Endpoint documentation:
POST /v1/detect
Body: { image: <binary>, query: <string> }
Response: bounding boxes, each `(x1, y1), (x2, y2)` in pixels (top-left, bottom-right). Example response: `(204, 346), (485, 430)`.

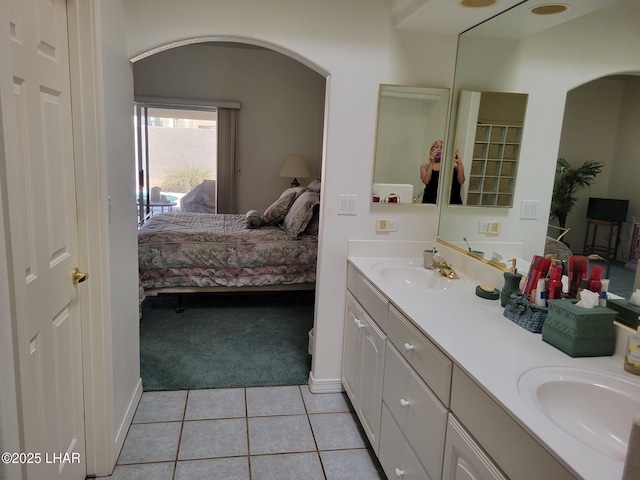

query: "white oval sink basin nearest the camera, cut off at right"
(518, 367), (640, 462)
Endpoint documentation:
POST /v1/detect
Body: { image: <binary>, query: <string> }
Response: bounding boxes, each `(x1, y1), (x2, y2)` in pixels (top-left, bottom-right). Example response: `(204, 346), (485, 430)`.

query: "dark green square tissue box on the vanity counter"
(542, 300), (616, 357)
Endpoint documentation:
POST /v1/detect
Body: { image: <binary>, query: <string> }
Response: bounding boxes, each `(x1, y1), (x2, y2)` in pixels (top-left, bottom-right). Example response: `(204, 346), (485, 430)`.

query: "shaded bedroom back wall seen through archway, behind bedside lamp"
(133, 44), (325, 213)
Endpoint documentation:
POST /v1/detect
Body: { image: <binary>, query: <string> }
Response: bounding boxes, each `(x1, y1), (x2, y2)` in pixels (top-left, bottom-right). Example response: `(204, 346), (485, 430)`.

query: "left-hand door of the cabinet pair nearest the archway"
(342, 292), (364, 408)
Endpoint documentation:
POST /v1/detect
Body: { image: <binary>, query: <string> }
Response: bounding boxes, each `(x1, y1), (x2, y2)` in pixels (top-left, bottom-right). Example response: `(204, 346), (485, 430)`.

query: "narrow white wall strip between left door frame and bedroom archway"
(99, 0), (140, 432)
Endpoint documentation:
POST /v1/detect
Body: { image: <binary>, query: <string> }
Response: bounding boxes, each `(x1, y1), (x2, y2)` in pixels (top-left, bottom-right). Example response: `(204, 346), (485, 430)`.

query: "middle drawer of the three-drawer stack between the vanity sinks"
(383, 342), (447, 478)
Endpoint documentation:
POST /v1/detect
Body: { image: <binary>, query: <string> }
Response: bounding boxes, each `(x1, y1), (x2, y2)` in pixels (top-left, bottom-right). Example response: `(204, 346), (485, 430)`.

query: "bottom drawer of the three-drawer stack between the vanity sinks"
(378, 403), (432, 480)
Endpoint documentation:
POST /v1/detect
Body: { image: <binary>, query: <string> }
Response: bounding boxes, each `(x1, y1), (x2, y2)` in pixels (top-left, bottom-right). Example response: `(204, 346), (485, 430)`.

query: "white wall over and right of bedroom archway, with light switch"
(121, 0), (457, 388)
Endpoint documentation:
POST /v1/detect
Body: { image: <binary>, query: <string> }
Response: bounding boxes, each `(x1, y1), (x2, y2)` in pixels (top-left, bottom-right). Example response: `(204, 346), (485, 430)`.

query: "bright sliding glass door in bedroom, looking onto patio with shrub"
(135, 103), (218, 223)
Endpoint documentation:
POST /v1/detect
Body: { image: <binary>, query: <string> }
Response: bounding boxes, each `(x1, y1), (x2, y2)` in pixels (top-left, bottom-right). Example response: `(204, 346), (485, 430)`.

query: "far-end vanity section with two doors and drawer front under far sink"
(342, 272), (387, 453)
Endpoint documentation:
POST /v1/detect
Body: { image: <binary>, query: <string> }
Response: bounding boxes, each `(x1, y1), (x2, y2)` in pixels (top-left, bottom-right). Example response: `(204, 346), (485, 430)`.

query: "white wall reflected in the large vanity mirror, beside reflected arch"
(441, 0), (640, 258)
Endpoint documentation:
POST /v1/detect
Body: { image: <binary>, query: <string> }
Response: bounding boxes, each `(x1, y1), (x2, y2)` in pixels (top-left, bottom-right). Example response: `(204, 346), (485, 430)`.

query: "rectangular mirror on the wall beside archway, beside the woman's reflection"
(372, 85), (449, 205)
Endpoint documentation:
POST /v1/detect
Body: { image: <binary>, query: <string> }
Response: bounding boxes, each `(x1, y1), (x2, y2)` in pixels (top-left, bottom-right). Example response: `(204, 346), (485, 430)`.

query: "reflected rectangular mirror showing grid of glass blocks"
(450, 90), (528, 207)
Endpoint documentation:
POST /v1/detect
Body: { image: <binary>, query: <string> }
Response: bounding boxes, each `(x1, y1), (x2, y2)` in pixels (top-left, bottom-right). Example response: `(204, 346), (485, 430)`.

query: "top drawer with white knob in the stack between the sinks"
(387, 305), (453, 406)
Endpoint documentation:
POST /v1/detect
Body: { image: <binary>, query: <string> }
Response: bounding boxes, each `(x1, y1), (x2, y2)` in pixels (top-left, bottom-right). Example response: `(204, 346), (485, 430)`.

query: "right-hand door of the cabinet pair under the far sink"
(357, 313), (387, 452)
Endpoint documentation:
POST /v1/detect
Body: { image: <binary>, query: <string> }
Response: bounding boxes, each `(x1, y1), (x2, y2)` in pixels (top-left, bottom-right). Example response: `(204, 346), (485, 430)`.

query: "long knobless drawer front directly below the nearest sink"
(451, 367), (575, 480)
